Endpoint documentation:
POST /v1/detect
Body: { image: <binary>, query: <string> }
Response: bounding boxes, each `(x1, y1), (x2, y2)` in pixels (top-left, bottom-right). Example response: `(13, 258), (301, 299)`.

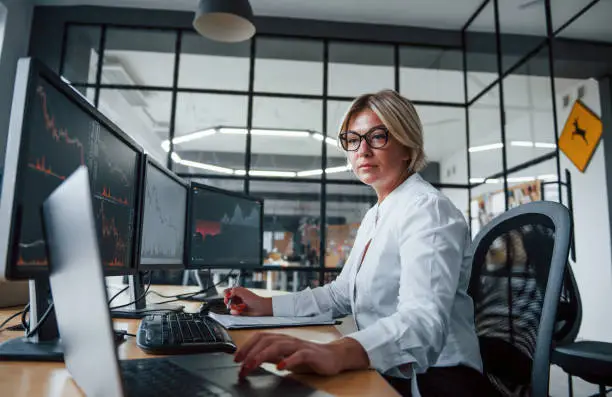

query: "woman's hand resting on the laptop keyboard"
(234, 332), (370, 377)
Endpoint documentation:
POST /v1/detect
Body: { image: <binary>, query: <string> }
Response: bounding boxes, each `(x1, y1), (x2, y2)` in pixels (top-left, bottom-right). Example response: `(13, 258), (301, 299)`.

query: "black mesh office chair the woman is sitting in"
(468, 201), (572, 397)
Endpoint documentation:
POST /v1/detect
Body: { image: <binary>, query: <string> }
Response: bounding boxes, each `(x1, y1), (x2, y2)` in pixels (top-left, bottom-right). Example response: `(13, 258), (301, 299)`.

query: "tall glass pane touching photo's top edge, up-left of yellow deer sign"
(498, 0), (554, 72)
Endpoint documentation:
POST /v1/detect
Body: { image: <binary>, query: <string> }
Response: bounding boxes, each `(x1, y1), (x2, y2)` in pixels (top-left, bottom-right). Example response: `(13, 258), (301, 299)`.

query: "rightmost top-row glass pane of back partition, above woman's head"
(400, 46), (465, 103)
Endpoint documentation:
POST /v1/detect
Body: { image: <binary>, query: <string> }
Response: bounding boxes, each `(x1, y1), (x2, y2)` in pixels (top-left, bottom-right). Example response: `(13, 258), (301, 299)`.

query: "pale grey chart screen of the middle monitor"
(139, 161), (189, 270)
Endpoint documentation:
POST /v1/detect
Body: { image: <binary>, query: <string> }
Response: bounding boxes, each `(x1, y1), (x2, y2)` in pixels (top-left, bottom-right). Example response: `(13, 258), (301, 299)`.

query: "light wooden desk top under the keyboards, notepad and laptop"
(0, 286), (398, 397)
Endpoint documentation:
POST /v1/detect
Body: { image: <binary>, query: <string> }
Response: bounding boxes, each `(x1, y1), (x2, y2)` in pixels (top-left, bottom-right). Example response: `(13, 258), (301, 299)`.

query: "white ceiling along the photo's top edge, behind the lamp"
(35, 0), (612, 41)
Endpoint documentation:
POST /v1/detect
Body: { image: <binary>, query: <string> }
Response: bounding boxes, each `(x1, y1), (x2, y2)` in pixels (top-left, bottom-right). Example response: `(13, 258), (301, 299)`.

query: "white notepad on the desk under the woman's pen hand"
(208, 312), (337, 329)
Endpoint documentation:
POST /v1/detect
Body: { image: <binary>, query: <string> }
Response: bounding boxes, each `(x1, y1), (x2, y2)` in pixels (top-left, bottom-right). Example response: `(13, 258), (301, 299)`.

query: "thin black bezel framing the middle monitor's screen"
(136, 154), (190, 272)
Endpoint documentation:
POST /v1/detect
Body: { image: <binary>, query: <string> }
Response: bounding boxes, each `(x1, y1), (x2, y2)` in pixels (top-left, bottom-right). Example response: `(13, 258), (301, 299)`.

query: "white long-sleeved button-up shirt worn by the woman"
(272, 174), (482, 389)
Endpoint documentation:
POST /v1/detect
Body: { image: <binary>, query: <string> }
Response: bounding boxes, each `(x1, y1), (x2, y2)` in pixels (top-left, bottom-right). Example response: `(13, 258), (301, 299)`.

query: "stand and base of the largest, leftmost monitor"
(0, 278), (64, 362)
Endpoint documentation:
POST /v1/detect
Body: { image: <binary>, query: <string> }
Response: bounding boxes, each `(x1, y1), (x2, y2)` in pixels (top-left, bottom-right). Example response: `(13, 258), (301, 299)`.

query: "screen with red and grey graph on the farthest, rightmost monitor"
(188, 183), (263, 268)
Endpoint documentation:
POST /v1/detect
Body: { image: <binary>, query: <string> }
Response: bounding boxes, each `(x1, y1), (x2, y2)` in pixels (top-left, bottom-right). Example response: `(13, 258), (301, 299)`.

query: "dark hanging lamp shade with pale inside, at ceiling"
(193, 0), (255, 43)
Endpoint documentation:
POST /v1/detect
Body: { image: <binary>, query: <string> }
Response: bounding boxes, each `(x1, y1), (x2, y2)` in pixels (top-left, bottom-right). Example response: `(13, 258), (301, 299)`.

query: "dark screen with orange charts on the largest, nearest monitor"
(12, 76), (139, 268)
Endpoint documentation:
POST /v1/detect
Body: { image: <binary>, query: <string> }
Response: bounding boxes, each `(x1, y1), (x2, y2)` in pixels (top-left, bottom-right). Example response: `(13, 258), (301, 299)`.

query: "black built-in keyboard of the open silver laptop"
(120, 359), (232, 397)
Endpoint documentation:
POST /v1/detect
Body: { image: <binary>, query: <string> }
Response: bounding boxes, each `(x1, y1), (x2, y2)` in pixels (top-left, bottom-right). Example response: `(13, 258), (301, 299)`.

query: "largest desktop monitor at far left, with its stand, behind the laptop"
(0, 58), (143, 359)
